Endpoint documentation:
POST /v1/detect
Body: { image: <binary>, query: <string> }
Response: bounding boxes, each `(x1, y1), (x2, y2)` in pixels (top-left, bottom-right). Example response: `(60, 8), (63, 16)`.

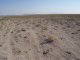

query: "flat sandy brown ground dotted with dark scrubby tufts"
(0, 15), (80, 60)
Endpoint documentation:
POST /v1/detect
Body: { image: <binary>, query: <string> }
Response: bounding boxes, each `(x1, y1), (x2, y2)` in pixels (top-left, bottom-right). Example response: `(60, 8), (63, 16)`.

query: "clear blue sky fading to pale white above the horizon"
(0, 0), (80, 15)
